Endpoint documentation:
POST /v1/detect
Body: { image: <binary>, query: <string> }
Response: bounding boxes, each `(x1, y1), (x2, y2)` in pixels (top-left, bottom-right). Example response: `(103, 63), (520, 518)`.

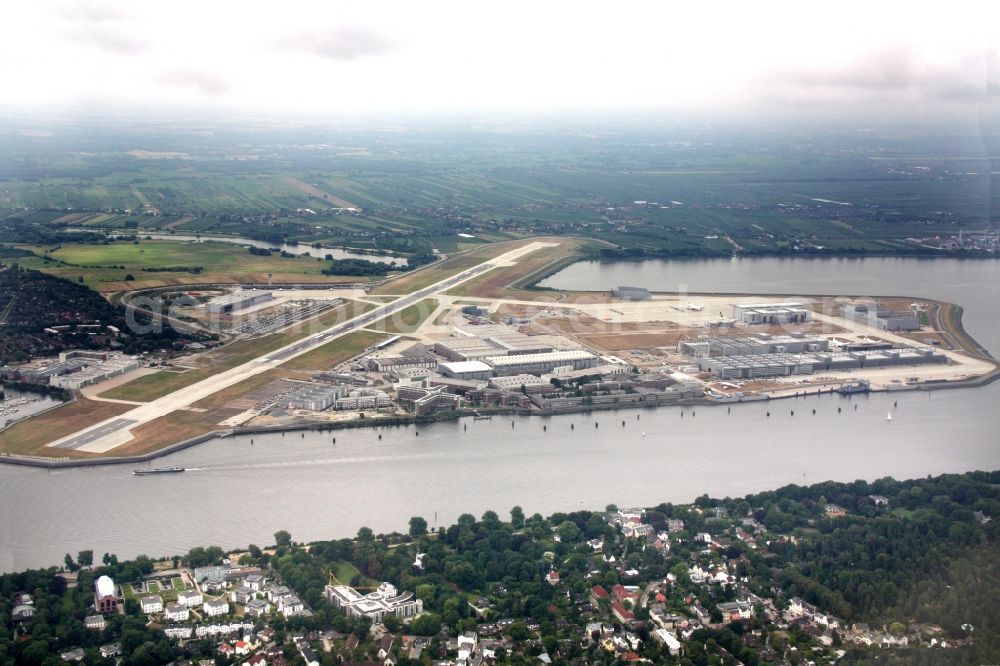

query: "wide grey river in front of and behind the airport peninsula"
(0, 259), (1000, 571)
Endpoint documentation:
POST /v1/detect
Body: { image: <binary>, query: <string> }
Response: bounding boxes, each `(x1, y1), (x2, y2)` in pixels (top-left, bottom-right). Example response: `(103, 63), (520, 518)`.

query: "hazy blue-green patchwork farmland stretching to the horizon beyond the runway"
(0, 121), (1000, 260)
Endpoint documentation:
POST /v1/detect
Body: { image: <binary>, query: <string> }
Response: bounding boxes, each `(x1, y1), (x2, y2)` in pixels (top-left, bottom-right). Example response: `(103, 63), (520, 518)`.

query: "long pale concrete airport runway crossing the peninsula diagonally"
(47, 242), (551, 453)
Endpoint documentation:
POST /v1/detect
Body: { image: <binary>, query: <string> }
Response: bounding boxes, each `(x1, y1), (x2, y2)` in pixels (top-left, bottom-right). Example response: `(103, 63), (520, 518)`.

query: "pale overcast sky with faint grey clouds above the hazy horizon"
(0, 0), (1000, 121)
